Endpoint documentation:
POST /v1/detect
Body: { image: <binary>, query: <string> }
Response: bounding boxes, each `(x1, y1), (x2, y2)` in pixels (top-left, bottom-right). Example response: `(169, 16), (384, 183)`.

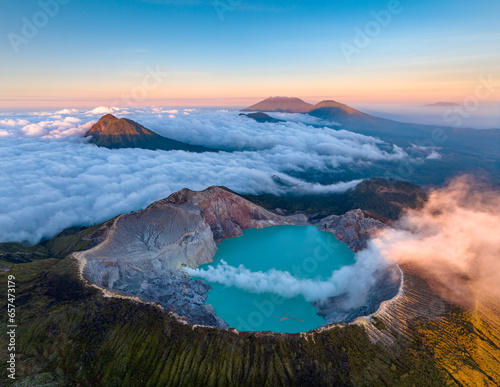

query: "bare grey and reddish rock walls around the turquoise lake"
(76, 187), (397, 328)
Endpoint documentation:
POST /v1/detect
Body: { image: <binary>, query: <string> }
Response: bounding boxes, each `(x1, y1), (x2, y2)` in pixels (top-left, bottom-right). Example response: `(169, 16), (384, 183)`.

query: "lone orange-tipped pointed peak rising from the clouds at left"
(85, 114), (218, 153)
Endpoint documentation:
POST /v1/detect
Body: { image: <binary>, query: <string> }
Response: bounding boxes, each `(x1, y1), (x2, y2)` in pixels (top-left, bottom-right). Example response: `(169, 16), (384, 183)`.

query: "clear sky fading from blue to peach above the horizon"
(0, 0), (500, 106)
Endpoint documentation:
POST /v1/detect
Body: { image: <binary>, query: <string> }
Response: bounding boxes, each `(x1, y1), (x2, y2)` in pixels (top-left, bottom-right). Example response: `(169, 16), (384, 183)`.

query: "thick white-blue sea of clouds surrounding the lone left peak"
(0, 107), (436, 243)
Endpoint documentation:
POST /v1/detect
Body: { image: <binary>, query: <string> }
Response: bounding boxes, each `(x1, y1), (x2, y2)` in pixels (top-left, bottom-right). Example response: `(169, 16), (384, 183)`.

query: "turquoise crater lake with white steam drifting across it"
(194, 226), (355, 333)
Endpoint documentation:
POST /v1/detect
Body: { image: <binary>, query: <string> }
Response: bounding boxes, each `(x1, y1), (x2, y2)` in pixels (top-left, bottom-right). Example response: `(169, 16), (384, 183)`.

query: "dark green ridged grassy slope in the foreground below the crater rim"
(0, 258), (500, 386)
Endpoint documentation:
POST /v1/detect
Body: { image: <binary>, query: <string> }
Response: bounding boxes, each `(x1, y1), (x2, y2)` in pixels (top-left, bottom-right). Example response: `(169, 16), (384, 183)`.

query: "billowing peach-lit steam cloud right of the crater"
(366, 176), (500, 306)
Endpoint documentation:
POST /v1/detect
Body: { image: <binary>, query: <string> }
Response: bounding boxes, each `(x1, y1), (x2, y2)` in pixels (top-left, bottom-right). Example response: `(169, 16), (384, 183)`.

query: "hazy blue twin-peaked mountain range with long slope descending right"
(243, 97), (500, 184)
